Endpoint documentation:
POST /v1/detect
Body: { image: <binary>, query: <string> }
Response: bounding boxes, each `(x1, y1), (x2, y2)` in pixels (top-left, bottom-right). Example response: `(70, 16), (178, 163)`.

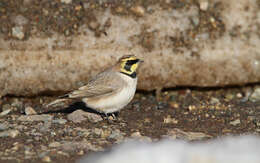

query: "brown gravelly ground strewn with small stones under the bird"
(0, 86), (260, 162)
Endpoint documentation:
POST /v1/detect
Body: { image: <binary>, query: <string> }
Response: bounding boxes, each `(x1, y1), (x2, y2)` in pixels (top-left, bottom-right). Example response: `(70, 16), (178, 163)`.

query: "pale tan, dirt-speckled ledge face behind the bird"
(0, 0), (260, 96)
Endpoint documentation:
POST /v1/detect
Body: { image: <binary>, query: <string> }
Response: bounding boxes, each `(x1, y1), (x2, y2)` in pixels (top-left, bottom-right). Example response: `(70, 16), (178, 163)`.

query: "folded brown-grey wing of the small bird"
(67, 71), (125, 98)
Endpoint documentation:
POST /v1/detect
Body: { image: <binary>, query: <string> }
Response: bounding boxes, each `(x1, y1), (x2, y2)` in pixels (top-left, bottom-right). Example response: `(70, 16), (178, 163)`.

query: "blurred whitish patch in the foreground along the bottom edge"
(79, 136), (260, 163)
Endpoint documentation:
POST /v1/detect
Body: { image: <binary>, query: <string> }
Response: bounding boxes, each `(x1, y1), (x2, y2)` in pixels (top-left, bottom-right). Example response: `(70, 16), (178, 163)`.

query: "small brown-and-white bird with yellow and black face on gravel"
(47, 55), (143, 117)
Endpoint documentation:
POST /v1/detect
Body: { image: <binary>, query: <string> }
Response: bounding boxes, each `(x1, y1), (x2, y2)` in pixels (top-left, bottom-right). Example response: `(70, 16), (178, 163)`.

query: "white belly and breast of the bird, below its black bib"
(84, 74), (137, 113)
